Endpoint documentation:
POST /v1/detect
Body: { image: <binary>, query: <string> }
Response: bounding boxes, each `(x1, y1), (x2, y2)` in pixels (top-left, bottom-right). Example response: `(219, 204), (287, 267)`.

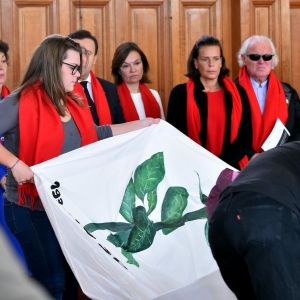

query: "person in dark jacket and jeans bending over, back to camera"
(209, 142), (300, 300)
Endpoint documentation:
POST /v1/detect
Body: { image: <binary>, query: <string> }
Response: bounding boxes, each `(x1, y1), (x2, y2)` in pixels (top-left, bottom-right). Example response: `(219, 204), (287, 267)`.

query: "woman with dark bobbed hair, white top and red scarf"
(112, 42), (165, 122)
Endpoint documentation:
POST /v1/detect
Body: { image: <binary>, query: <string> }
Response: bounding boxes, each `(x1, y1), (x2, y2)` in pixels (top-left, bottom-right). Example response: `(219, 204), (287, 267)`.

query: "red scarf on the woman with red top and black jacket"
(187, 77), (248, 168)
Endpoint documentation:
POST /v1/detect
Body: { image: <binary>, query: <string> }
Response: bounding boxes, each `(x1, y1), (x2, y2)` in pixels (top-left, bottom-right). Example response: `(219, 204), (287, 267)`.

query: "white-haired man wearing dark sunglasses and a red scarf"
(236, 35), (300, 156)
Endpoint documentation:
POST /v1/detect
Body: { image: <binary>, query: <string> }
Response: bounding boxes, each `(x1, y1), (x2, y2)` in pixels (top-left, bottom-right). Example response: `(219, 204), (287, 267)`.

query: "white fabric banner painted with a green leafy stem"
(32, 121), (235, 300)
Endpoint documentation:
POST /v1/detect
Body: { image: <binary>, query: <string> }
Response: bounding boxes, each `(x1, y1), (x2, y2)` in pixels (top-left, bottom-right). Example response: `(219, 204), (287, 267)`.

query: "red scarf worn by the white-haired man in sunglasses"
(239, 66), (288, 152)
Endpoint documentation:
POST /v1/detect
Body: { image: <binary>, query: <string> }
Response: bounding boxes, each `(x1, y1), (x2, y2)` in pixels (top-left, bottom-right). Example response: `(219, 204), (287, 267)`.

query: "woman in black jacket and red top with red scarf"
(167, 36), (251, 169)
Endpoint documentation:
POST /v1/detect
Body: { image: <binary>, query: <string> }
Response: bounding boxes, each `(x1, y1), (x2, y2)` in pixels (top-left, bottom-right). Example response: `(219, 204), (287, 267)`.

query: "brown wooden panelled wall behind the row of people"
(0, 0), (300, 109)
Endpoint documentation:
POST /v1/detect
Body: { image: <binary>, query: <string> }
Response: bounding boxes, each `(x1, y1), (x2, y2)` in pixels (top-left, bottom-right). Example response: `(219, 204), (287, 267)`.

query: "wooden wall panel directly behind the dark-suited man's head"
(70, 0), (115, 80)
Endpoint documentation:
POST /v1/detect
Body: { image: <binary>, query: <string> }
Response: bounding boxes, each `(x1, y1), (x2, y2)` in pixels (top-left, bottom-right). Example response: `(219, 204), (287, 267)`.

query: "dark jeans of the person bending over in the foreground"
(209, 192), (300, 300)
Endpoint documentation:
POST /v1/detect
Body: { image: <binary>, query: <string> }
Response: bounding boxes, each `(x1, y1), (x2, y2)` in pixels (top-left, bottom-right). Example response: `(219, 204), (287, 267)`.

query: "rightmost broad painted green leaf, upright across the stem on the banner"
(161, 186), (189, 234)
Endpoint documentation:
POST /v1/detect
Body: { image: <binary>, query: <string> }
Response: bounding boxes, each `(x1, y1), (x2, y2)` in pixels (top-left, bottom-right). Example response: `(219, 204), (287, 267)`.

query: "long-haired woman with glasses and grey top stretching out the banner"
(0, 35), (158, 299)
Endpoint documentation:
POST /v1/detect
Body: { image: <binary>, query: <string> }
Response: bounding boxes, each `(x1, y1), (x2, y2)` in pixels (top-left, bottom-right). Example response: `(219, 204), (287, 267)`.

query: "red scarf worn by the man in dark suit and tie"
(90, 72), (112, 125)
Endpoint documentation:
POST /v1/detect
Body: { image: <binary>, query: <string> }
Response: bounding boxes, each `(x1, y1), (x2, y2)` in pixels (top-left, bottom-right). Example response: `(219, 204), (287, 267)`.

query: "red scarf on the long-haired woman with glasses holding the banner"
(18, 82), (98, 209)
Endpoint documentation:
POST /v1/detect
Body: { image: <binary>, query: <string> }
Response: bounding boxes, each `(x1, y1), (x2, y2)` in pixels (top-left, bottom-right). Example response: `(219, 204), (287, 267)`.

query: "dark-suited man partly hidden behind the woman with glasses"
(69, 30), (125, 125)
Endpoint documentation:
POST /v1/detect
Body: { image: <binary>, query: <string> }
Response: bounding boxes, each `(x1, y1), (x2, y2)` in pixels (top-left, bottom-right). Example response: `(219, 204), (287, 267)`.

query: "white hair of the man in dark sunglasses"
(238, 35), (279, 69)
